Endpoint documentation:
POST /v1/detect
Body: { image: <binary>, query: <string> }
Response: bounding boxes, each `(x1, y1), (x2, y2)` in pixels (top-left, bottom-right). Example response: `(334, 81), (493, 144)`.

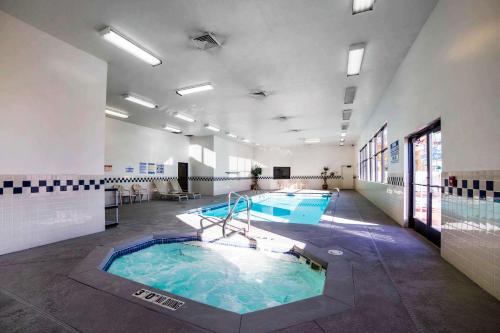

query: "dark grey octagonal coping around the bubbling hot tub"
(69, 232), (354, 333)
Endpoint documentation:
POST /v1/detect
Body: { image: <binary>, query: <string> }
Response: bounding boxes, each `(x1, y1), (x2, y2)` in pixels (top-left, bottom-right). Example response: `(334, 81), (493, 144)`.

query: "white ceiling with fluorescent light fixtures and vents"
(0, 0), (437, 146)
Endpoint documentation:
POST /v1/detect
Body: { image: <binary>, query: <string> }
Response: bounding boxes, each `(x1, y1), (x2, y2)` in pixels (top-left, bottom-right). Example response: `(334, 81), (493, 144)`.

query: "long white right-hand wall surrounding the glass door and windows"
(358, 0), (500, 297)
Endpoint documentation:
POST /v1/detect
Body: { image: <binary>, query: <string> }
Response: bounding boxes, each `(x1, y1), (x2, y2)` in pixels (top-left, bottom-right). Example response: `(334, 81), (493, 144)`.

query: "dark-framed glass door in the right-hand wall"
(408, 121), (443, 246)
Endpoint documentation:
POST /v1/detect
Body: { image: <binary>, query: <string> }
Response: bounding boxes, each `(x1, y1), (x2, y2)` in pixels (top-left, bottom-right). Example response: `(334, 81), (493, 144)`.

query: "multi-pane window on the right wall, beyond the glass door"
(359, 124), (389, 183)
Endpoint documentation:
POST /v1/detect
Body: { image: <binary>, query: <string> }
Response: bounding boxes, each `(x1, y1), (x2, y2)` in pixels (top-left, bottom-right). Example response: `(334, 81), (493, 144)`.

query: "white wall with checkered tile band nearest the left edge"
(0, 11), (107, 254)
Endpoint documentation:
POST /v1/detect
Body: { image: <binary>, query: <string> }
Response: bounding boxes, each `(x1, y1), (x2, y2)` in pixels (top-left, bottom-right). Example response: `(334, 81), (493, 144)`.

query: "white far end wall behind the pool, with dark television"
(254, 145), (355, 189)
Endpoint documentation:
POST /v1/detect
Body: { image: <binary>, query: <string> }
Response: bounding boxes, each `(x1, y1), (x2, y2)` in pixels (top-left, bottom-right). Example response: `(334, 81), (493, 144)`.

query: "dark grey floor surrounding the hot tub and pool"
(0, 191), (500, 333)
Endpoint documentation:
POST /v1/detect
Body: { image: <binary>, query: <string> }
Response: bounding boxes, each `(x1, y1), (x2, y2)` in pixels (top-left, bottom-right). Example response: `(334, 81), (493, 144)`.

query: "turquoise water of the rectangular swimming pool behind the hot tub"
(201, 193), (331, 224)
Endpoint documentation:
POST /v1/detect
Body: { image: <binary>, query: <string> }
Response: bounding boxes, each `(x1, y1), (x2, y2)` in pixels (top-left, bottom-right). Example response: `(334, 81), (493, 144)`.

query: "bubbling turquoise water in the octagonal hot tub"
(107, 241), (325, 314)
